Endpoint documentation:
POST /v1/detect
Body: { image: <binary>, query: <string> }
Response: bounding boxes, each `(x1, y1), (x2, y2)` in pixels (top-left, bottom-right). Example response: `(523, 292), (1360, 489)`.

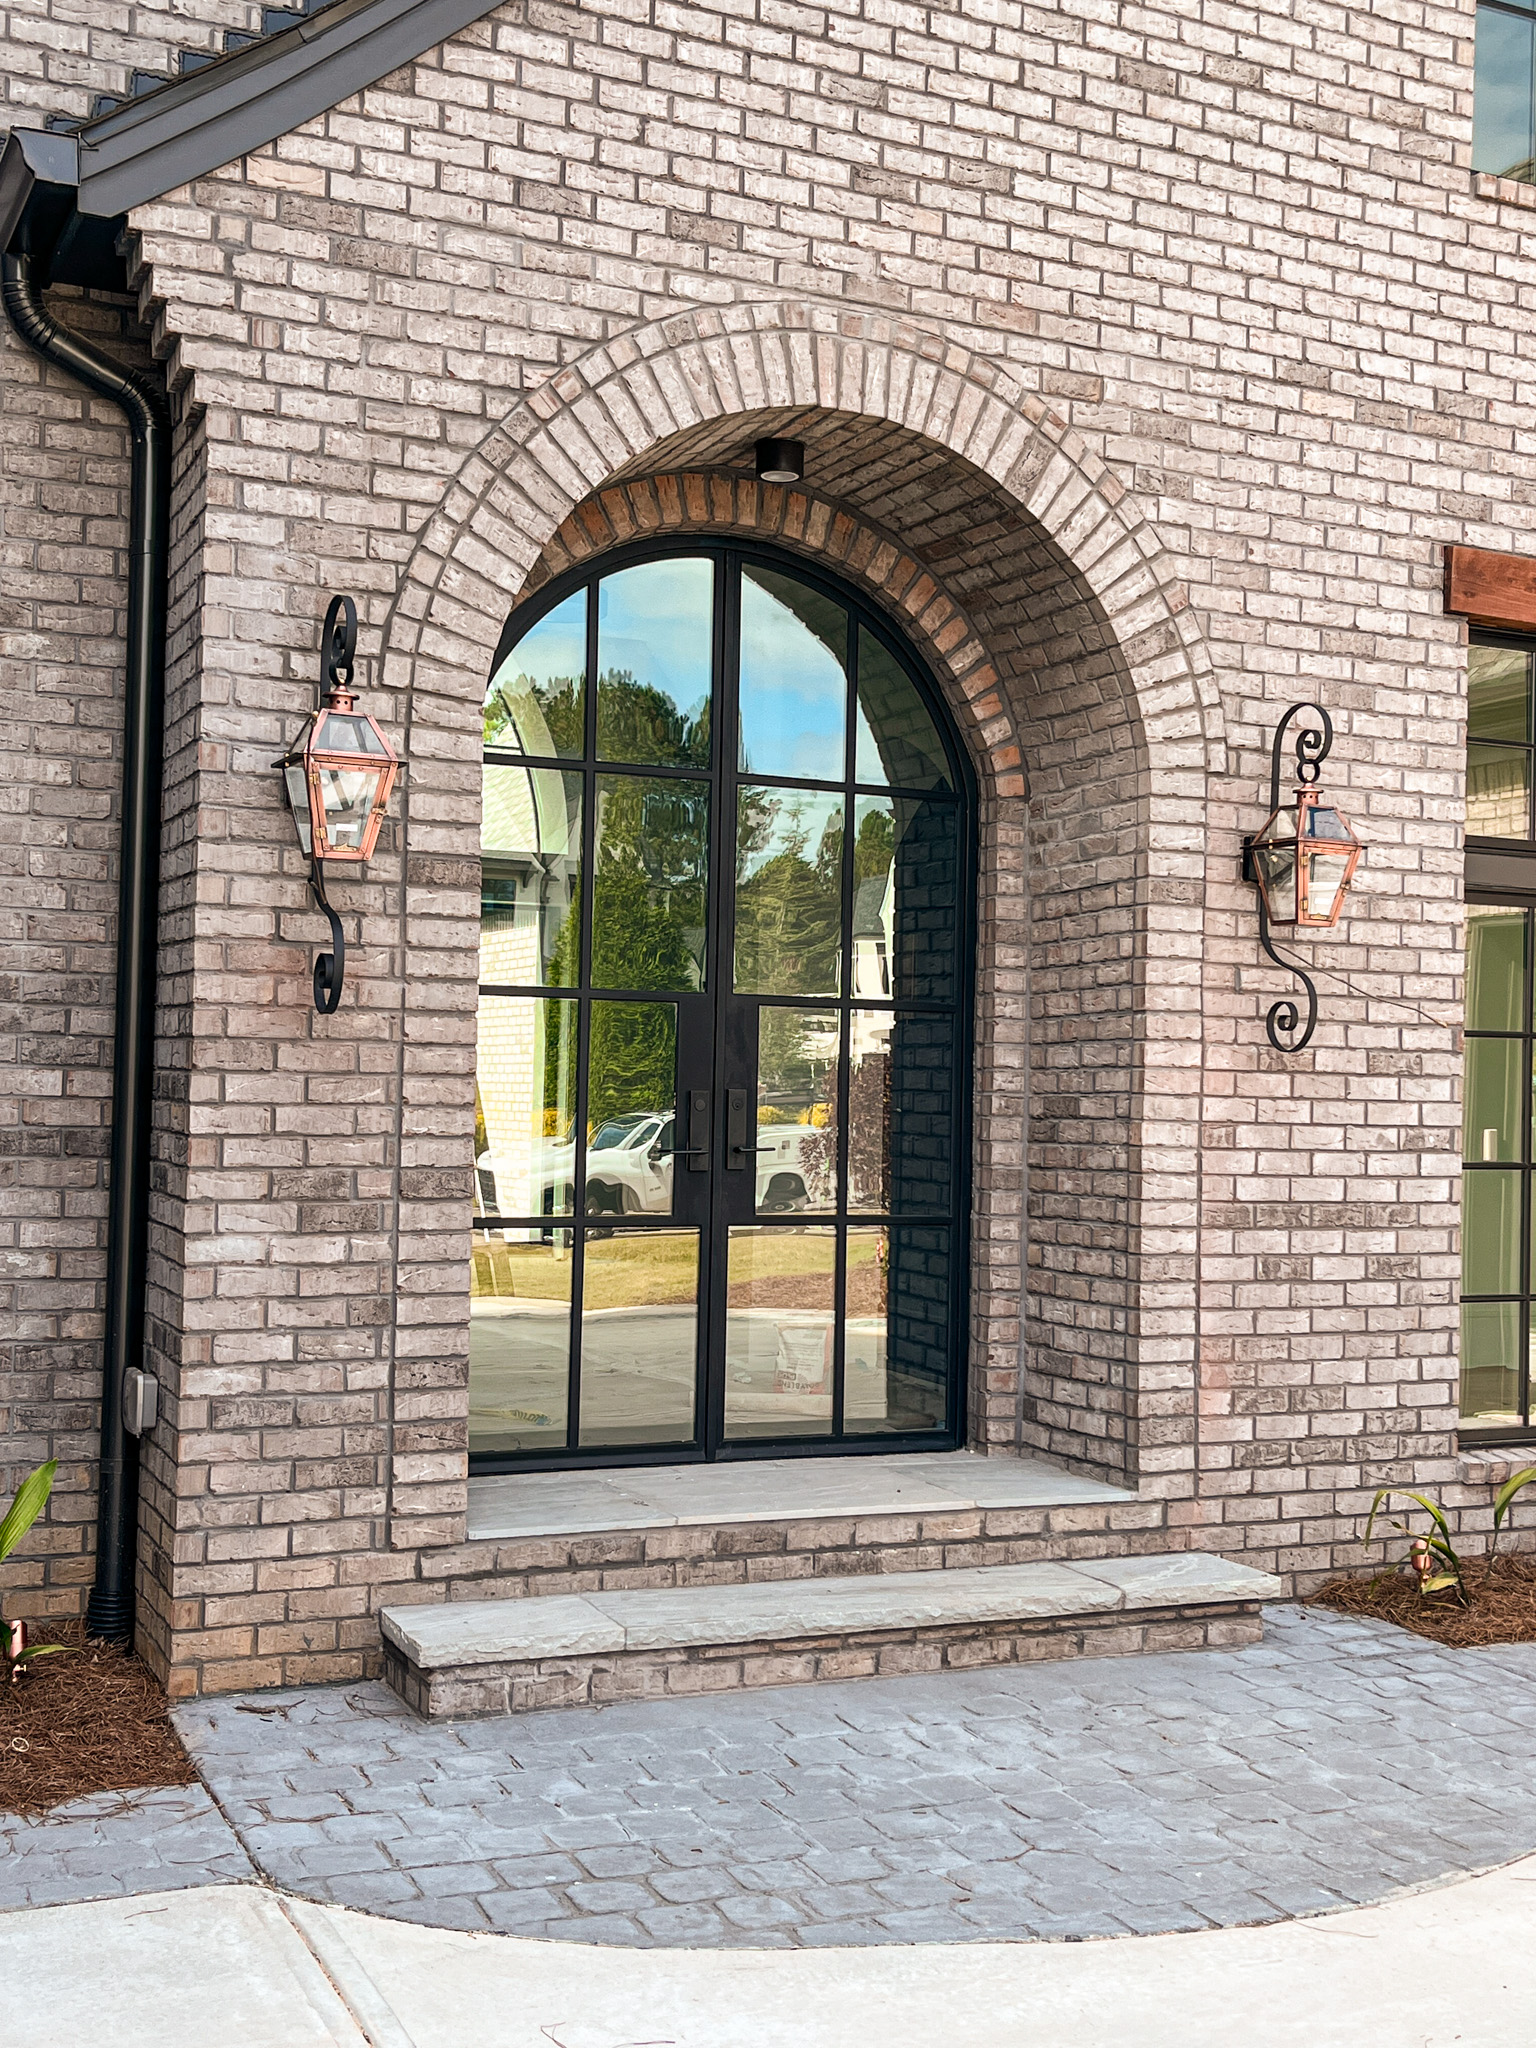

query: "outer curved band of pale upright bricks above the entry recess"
(383, 301), (1225, 798)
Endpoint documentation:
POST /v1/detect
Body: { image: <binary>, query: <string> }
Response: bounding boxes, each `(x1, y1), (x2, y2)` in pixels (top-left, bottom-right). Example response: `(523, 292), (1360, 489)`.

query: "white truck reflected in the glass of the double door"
(475, 1112), (834, 1217)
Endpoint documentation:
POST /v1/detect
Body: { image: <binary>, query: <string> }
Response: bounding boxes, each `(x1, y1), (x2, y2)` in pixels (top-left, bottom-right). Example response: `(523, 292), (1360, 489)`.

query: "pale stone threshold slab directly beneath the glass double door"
(469, 1450), (1137, 1542)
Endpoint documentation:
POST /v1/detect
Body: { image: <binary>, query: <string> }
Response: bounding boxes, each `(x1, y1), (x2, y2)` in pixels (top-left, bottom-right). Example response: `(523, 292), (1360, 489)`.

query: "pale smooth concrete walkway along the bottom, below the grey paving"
(4, 1858), (1536, 2048)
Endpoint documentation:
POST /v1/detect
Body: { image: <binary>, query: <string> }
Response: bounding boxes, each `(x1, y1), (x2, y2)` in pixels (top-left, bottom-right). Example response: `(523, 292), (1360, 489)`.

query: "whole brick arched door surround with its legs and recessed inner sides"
(383, 305), (1223, 1515)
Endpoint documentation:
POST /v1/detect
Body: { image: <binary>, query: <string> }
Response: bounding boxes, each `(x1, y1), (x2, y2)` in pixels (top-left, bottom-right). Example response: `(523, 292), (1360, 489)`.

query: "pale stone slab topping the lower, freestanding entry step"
(379, 1550), (1282, 1671)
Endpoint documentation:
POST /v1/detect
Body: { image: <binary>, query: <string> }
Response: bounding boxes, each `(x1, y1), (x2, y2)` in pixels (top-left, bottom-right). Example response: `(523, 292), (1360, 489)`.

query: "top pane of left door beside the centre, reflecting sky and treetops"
(598, 555), (715, 768)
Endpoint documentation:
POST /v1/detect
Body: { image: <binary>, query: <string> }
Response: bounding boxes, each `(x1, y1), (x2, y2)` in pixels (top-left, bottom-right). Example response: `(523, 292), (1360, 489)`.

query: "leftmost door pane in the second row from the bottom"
(475, 995), (575, 1217)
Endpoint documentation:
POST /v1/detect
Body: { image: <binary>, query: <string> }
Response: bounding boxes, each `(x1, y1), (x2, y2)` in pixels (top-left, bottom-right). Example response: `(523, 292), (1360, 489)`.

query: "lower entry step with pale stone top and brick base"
(379, 1550), (1282, 1718)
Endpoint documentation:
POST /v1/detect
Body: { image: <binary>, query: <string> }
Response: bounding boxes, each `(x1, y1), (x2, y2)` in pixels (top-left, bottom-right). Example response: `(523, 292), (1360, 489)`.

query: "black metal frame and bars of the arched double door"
(469, 532), (979, 1475)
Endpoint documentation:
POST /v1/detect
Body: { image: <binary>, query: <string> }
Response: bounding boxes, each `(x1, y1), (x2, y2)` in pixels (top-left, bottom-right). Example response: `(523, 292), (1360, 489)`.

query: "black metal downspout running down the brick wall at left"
(0, 256), (170, 1642)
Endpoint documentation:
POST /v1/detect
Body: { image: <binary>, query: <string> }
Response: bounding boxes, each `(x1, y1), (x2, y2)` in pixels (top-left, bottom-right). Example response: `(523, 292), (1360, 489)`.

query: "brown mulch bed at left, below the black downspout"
(0, 1622), (197, 1812)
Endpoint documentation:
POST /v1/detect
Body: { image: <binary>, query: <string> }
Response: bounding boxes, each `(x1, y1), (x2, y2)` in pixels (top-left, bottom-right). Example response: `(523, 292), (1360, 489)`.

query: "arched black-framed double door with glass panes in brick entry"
(469, 543), (973, 1468)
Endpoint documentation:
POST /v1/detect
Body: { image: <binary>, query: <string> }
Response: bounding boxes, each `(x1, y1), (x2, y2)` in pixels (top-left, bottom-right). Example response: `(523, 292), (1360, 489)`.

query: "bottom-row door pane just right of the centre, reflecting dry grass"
(725, 1227), (838, 1440)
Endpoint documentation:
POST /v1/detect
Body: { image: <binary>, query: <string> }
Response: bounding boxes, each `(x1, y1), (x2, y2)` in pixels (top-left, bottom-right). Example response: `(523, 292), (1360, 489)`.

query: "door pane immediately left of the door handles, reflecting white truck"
(586, 1001), (678, 1217)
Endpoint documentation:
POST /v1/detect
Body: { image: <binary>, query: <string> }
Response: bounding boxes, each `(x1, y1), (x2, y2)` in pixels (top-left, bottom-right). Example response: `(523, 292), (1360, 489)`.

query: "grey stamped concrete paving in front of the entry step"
(0, 1608), (1536, 1948)
